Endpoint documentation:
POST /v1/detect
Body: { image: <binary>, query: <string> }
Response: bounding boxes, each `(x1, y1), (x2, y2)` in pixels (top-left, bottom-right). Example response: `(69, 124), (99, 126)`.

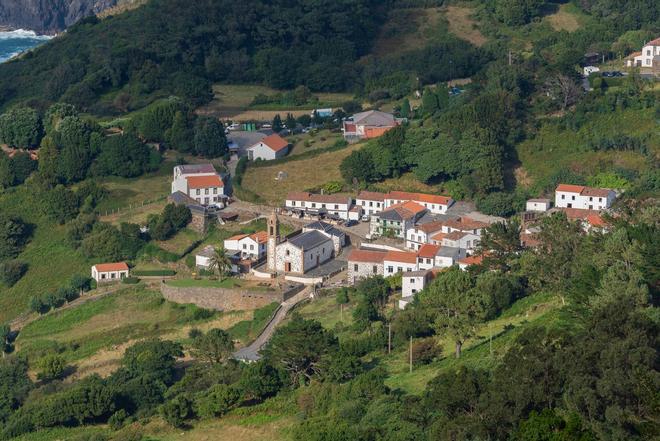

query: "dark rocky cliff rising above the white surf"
(0, 0), (120, 34)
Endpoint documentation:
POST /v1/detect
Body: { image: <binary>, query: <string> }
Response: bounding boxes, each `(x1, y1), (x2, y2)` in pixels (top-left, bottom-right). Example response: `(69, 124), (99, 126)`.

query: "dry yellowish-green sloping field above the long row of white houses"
(243, 144), (362, 204)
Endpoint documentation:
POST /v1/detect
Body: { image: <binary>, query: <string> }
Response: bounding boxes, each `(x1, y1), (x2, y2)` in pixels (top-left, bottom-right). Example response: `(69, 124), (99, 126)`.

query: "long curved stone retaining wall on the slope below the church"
(160, 283), (287, 311)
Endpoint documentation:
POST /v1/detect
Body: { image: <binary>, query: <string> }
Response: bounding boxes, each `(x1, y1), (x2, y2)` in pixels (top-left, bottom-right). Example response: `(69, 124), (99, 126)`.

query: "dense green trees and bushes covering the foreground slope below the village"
(0, 198), (660, 441)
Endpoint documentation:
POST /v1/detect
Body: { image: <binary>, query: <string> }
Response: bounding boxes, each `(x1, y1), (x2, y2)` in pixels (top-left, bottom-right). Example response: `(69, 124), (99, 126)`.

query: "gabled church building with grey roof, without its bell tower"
(275, 230), (334, 274)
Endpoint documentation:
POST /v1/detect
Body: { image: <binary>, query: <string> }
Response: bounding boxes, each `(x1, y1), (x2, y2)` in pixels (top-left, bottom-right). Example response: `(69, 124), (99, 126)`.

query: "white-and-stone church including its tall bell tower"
(267, 212), (346, 274)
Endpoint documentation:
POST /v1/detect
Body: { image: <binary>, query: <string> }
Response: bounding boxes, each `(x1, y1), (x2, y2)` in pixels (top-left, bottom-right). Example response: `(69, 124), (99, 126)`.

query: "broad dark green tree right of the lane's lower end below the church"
(263, 314), (338, 384)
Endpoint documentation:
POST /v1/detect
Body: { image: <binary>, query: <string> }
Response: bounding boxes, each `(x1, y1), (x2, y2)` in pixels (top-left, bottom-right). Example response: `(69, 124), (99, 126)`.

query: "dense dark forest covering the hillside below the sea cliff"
(0, 0), (381, 113)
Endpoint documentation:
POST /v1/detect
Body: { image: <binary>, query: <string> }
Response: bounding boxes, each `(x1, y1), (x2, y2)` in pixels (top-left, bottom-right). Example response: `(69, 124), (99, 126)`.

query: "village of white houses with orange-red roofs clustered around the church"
(92, 106), (617, 320)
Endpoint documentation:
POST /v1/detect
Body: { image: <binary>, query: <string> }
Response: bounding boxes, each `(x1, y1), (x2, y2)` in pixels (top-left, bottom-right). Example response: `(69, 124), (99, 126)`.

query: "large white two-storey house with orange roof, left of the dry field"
(172, 164), (225, 205)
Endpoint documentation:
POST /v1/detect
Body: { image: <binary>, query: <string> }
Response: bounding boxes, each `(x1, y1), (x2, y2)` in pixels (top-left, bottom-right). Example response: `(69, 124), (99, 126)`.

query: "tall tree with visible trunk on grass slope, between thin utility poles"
(420, 267), (482, 358)
